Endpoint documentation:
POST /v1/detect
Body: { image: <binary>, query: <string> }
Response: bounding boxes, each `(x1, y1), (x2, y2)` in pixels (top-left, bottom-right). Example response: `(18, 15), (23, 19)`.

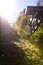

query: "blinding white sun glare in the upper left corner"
(0, 0), (16, 23)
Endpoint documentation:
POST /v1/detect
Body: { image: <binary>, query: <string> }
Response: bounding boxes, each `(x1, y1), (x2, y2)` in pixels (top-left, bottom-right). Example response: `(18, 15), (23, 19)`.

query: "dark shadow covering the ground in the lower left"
(0, 40), (32, 65)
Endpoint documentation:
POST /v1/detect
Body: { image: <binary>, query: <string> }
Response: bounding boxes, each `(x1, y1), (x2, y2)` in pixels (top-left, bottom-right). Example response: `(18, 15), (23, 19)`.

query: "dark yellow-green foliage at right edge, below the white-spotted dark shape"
(31, 21), (43, 49)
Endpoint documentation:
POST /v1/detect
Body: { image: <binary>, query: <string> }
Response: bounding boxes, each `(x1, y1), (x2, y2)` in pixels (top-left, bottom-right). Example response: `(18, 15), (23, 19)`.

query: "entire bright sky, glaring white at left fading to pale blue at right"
(0, 0), (37, 23)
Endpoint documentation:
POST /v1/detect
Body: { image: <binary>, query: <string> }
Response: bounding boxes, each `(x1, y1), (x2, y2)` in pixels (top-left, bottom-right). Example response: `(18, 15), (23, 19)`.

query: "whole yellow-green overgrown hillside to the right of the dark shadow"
(13, 10), (43, 65)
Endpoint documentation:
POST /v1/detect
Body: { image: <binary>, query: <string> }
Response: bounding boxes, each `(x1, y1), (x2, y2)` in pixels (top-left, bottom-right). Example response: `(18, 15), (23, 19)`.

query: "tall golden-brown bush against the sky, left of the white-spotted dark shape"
(15, 13), (31, 38)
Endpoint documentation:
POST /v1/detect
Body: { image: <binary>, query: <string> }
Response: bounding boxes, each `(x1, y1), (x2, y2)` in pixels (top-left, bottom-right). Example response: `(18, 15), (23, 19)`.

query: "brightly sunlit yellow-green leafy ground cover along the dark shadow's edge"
(13, 40), (43, 65)
